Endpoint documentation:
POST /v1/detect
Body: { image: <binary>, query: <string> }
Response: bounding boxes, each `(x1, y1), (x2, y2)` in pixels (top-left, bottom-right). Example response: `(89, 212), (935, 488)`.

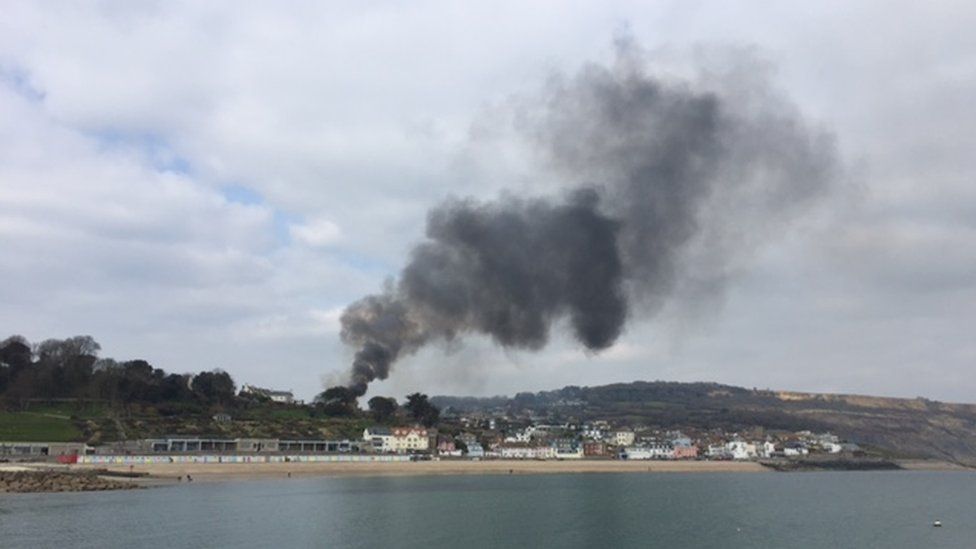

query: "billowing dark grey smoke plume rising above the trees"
(342, 41), (836, 394)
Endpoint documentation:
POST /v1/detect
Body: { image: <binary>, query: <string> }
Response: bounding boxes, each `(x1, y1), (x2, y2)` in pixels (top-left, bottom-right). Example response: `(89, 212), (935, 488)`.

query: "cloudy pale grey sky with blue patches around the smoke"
(0, 0), (976, 402)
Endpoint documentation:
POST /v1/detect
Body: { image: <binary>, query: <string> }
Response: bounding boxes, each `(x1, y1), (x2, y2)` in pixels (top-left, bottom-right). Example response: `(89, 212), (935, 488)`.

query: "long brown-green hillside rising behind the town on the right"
(431, 381), (976, 465)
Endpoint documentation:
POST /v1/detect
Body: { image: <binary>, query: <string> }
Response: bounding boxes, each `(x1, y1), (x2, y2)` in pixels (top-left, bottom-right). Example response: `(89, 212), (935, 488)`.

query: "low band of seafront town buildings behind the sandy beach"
(0, 408), (863, 464)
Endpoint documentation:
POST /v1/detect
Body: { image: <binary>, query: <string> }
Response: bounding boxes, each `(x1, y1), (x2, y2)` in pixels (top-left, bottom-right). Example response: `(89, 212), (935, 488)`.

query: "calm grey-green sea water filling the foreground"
(0, 472), (976, 549)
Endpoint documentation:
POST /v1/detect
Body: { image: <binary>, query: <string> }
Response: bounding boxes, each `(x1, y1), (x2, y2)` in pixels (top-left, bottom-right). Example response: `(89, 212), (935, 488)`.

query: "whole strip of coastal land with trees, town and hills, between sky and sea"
(0, 336), (976, 465)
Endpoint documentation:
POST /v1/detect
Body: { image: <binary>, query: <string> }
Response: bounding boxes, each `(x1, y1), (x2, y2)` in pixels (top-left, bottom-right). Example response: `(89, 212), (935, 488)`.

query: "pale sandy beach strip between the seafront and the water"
(72, 460), (769, 480)
